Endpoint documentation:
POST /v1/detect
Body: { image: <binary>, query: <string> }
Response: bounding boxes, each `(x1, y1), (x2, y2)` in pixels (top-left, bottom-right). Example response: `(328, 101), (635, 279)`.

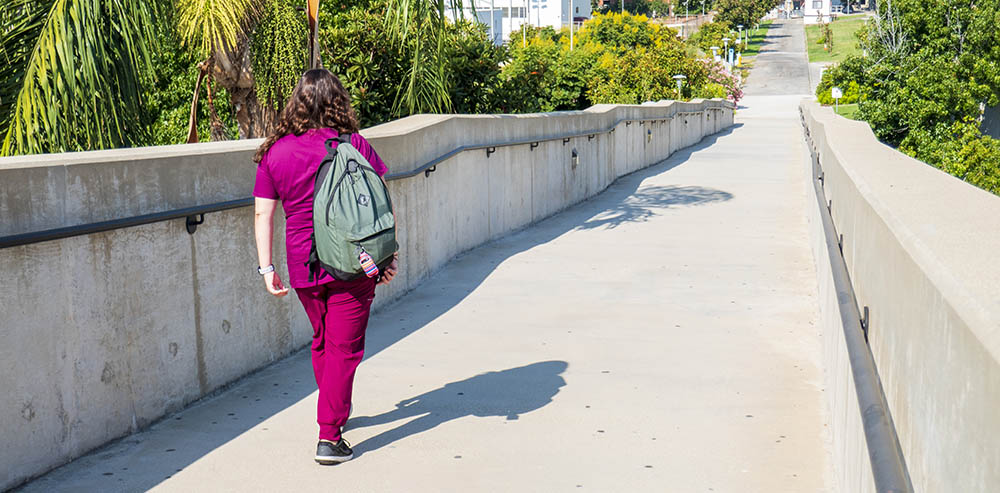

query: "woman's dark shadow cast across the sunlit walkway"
(345, 361), (569, 455)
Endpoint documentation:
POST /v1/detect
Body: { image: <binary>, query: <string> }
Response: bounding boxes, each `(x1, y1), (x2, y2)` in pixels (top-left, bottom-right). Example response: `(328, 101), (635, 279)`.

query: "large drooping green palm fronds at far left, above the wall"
(0, 0), (156, 155)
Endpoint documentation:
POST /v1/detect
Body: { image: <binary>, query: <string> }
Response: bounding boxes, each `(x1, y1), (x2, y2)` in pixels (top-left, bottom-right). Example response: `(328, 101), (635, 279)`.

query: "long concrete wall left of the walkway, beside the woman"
(0, 100), (733, 489)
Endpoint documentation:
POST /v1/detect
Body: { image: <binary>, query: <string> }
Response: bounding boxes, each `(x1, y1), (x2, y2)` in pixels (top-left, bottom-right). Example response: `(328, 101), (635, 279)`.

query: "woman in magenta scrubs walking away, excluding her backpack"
(253, 69), (398, 464)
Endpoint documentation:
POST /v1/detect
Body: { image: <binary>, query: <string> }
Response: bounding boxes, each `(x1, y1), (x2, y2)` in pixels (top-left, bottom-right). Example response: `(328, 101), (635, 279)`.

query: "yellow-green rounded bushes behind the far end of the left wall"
(502, 13), (740, 111)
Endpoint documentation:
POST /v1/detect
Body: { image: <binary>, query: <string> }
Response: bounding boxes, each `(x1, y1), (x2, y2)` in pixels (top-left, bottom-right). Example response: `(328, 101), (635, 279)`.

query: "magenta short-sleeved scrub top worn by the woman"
(253, 128), (388, 288)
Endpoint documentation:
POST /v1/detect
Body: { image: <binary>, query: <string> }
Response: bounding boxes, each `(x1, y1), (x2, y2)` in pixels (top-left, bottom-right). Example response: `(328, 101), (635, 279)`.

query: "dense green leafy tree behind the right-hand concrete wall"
(817, 0), (1000, 193)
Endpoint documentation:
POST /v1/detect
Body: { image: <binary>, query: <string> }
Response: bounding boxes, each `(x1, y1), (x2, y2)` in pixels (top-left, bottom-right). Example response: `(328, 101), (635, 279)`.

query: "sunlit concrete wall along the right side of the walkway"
(801, 102), (1000, 492)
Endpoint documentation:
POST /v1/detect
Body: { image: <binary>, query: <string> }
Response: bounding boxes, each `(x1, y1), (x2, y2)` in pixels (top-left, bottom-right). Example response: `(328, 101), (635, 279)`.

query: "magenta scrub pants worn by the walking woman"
(295, 277), (375, 442)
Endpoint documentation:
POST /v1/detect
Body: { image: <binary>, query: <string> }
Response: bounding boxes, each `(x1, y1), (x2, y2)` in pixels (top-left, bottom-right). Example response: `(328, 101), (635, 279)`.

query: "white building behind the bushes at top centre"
(448, 0), (592, 44)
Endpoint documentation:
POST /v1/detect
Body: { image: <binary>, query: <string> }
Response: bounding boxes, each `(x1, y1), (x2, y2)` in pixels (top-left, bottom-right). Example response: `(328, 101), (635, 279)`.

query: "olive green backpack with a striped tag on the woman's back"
(307, 134), (399, 281)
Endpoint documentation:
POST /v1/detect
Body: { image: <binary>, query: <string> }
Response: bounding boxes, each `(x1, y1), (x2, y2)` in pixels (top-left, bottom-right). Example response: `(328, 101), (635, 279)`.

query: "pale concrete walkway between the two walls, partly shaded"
(24, 21), (835, 492)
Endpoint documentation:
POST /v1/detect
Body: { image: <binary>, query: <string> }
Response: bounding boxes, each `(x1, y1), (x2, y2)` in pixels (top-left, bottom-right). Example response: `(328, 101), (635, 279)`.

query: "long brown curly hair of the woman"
(253, 68), (358, 163)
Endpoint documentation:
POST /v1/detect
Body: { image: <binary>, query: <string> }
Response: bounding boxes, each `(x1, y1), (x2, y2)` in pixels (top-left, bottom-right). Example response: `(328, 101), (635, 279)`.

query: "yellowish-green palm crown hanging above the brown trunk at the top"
(174, 0), (262, 58)
